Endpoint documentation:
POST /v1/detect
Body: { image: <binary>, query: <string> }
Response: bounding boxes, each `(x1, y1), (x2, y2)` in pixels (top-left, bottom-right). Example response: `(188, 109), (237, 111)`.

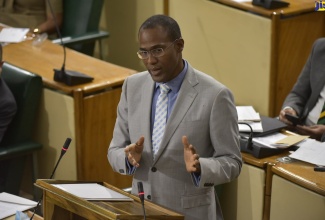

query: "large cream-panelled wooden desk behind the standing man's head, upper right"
(169, 0), (325, 117)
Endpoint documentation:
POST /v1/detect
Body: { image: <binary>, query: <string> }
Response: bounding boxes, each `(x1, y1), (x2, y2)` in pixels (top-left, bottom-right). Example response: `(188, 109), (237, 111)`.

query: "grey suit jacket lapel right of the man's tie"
(154, 65), (198, 163)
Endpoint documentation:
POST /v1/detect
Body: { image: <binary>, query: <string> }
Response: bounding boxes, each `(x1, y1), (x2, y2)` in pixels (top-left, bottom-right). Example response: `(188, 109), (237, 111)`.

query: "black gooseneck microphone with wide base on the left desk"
(47, 0), (94, 86)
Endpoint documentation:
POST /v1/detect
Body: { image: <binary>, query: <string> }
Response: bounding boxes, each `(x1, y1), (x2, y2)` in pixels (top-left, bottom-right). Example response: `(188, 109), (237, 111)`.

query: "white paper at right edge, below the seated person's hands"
(289, 138), (325, 166)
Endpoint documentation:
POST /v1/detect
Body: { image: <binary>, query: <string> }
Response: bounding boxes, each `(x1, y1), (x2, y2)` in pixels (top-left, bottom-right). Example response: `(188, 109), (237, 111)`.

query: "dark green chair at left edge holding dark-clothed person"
(0, 63), (43, 198)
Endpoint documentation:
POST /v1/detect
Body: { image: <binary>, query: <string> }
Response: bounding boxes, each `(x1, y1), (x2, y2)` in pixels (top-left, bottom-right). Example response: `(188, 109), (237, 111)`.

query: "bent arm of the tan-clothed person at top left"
(33, 0), (63, 34)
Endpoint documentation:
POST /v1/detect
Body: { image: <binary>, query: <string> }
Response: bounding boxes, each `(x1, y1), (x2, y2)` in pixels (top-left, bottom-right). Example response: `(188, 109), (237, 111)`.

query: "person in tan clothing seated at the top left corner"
(0, 0), (63, 35)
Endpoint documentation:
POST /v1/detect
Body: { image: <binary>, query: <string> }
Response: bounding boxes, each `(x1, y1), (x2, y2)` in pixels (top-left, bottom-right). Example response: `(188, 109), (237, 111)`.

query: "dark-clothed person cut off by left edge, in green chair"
(0, 44), (17, 192)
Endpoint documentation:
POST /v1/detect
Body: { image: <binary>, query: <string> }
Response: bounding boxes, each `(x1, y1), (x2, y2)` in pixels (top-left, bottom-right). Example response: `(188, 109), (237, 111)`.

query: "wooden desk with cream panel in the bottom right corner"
(270, 161), (325, 220)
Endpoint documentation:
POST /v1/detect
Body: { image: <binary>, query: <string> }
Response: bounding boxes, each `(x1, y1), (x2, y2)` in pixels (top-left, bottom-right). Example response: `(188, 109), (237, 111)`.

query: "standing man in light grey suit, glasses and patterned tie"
(108, 15), (242, 220)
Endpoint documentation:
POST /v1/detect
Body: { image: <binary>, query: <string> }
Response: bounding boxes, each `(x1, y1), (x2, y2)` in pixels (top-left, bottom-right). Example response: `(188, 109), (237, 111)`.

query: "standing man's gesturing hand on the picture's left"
(124, 136), (144, 167)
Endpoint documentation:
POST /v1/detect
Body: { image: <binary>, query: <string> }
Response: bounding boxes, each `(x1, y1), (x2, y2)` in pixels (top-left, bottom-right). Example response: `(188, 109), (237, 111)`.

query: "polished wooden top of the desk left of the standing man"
(3, 40), (135, 95)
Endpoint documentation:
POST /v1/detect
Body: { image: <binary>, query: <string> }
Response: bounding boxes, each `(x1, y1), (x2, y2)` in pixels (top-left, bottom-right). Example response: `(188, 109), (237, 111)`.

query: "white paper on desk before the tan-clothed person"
(0, 27), (29, 43)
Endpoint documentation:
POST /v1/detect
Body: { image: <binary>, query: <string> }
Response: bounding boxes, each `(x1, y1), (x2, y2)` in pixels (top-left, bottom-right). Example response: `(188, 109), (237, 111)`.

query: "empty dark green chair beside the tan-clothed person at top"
(52, 0), (109, 59)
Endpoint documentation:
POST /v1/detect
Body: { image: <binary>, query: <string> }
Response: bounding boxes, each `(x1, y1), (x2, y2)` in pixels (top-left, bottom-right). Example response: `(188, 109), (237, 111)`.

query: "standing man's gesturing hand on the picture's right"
(182, 136), (201, 173)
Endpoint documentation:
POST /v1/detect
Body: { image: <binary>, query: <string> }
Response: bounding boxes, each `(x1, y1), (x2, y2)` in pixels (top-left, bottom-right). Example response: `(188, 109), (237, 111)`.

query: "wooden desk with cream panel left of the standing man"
(3, 41), (136, 188)
